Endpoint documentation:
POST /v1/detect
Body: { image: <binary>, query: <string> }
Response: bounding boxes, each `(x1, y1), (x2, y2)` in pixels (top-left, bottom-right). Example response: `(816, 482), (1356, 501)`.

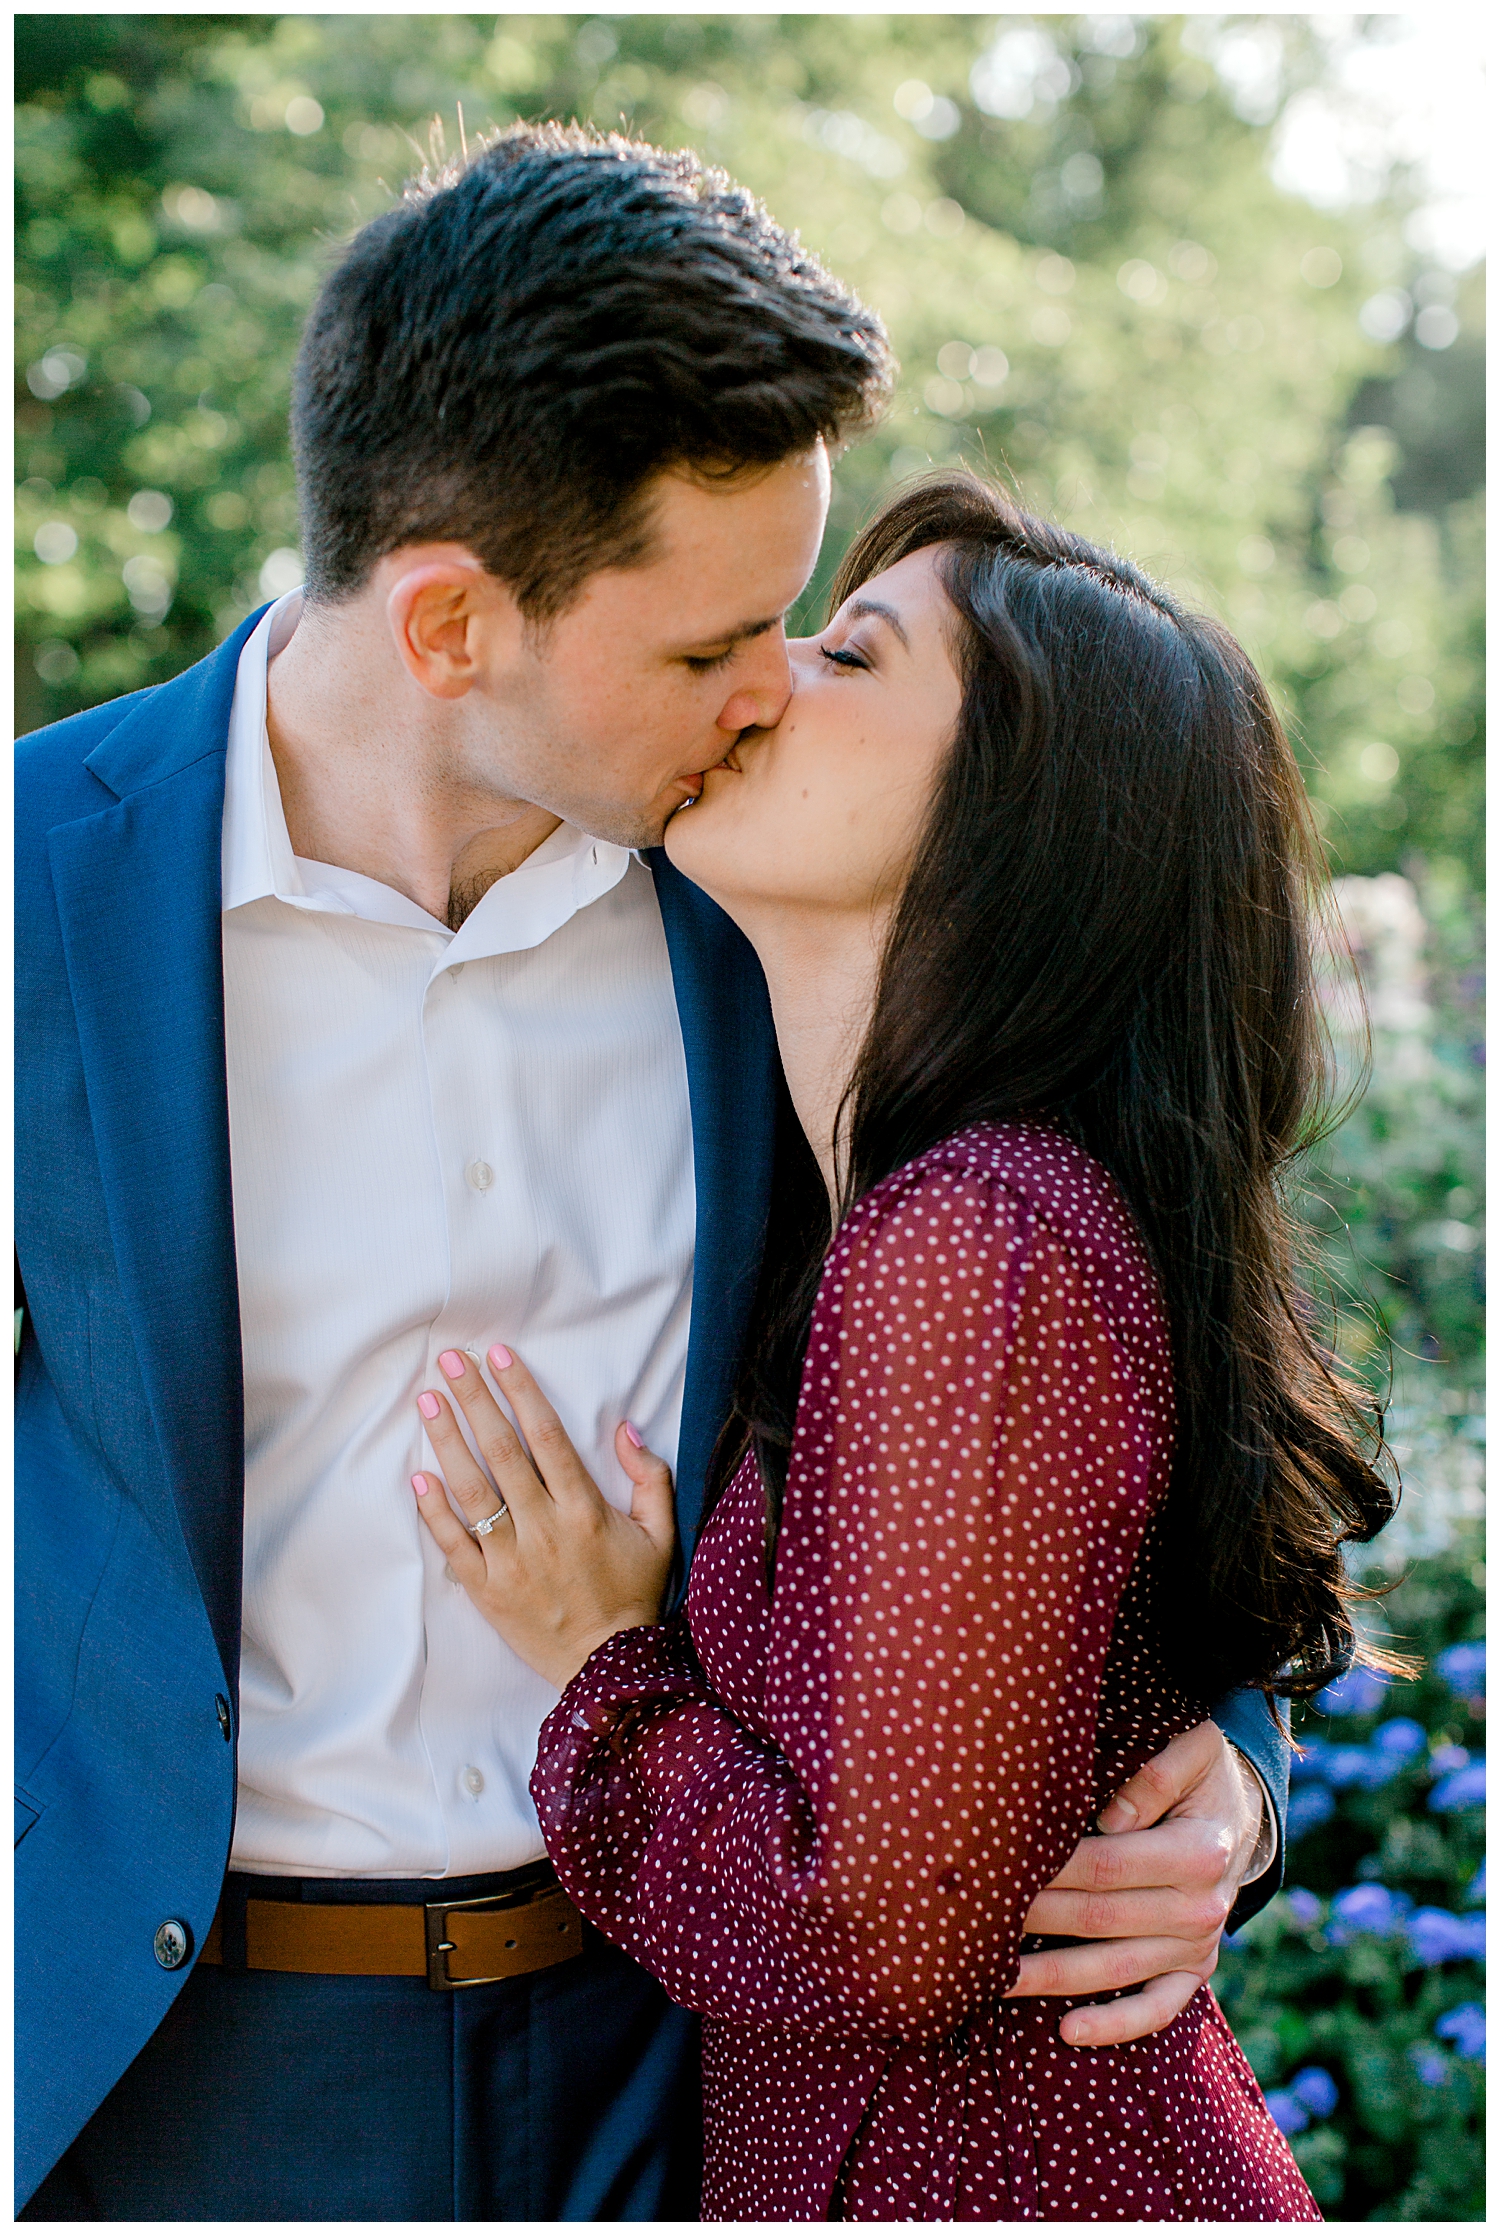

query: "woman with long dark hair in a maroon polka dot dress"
(416, 476), (1390, 2220)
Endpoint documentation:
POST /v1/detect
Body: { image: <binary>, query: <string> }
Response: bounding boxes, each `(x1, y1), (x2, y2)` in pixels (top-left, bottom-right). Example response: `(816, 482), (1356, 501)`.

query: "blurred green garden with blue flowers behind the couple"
(16, 16), (1484, 2220)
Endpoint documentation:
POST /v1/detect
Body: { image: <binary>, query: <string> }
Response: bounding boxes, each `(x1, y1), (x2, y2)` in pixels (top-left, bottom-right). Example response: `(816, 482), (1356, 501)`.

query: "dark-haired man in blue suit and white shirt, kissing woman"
(18, 127), (1283, 2220)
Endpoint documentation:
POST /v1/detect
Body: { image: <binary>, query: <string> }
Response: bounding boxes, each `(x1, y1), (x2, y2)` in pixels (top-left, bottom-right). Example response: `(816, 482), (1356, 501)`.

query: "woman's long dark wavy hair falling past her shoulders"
(713, 474), (1395, 1699)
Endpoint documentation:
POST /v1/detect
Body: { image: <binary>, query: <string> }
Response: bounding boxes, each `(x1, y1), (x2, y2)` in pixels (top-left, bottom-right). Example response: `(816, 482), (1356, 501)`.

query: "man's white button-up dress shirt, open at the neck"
(224, 593), (695, 1878)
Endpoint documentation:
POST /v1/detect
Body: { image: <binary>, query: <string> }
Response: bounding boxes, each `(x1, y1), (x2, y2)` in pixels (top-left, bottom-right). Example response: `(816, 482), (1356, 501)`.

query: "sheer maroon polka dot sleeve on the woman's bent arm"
(532, 1156), (1169, 2039)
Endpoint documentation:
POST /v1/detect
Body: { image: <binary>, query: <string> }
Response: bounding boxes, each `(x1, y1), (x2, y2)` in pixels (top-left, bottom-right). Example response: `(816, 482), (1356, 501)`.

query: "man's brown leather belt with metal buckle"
(199, 1872), (583, 1988)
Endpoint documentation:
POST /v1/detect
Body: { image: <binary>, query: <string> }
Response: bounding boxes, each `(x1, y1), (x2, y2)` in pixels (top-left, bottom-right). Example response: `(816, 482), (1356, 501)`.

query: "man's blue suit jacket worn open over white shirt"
(16, 615), (1285, 2200)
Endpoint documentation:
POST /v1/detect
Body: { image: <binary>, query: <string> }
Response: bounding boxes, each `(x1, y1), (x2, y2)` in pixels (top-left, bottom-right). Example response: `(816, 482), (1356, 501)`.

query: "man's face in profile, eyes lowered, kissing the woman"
(467, 443), (829, 845)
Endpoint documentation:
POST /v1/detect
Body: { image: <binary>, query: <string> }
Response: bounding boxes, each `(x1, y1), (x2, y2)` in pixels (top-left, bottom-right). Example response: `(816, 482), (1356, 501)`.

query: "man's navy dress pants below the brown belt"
(20, 1880), (702, 2220)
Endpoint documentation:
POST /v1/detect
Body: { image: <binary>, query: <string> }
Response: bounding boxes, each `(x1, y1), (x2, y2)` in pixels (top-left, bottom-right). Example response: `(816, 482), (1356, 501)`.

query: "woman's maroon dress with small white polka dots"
(532, 1125), (1319, 2220)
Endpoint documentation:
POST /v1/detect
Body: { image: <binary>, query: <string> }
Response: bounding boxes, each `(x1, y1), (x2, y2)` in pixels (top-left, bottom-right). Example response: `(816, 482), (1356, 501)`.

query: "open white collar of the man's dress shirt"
(221, 590), (630, 968)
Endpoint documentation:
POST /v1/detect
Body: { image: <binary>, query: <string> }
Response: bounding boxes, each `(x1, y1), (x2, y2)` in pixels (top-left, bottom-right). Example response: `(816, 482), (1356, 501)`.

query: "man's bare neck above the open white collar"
(266, 608), (559, 930)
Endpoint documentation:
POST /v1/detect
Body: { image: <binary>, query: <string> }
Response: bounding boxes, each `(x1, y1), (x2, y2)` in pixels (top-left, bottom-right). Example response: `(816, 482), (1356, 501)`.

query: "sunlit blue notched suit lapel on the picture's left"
(47, 615), (267, 1679)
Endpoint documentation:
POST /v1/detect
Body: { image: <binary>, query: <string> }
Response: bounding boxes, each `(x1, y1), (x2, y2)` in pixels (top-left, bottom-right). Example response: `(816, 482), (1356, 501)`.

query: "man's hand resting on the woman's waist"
(1008, 1724), (1265, 2048)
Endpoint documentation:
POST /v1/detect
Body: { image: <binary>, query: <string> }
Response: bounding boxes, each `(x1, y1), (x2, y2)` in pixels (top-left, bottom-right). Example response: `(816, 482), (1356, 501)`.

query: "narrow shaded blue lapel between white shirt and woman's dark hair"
(651, 850), (778, 1563)
